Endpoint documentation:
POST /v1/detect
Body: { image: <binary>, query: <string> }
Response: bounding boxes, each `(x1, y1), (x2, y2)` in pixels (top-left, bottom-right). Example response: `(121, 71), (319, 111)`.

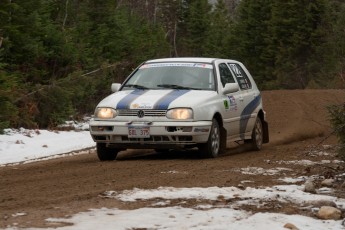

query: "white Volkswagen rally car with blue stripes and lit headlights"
(90, 58), (269, 161)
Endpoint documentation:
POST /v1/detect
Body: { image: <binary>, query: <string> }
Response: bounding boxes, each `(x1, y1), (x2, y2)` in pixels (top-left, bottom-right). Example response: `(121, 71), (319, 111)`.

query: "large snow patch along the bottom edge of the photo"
(42, 207), (344, 230)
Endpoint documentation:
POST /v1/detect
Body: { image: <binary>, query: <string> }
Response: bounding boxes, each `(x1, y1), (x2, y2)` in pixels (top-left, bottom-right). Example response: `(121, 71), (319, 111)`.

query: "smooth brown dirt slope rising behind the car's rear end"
(262, 90), (345, 144)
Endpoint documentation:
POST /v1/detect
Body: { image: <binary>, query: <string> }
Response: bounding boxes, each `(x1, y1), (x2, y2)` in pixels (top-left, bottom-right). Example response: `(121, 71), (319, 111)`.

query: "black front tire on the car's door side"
(199, 119), (221, 158)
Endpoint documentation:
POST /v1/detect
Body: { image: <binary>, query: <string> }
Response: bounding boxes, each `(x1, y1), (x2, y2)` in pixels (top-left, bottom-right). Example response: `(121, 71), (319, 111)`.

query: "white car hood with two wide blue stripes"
(97, 89), (217, 110)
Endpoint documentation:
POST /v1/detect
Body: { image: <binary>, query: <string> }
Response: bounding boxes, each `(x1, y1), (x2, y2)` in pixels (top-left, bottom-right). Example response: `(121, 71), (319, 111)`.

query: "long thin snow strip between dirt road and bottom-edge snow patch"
(101, 185), (345, 209)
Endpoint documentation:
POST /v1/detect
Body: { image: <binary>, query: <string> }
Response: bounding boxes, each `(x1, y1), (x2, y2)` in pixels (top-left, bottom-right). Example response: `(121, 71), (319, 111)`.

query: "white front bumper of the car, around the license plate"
(90, 120), (212, 149)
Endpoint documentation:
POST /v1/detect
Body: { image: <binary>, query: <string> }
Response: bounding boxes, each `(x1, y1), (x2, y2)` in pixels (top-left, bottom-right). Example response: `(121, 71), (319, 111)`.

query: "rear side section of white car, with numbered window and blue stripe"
(227, 62), (261, 139)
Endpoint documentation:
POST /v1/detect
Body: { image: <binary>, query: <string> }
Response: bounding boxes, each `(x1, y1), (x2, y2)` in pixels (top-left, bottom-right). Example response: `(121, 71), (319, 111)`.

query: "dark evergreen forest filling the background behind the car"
(0, 0), (345, 130)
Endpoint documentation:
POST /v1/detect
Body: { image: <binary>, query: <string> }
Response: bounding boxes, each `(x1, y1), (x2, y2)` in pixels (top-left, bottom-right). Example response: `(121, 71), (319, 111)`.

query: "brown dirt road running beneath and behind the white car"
(0, 90), (345, 228)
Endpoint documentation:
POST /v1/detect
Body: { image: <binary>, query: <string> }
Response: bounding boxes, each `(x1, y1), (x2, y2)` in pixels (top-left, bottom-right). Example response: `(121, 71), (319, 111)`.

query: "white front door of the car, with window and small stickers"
(217, 62), (243, 138)
